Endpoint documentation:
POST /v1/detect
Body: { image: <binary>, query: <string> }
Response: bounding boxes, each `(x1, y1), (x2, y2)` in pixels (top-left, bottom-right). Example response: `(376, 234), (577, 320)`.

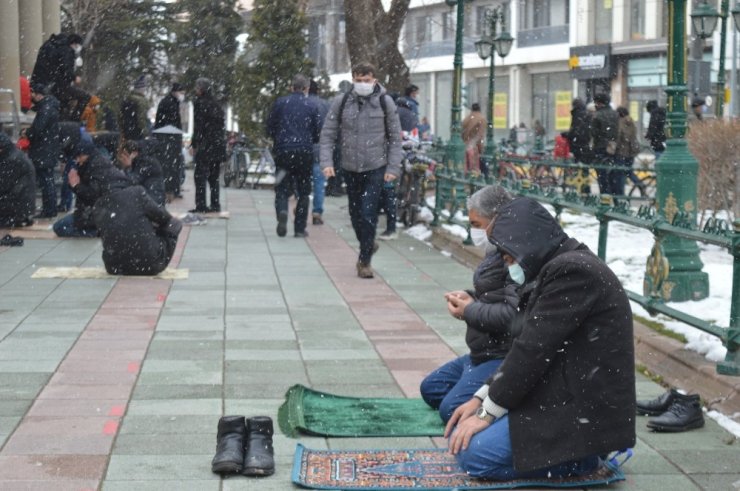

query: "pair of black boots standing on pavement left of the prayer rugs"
(211, 416), (275, 477)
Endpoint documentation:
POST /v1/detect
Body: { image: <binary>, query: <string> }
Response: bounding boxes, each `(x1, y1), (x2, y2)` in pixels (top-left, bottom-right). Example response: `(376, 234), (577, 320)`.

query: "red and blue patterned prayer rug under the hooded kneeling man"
(292, 444), (625, 491)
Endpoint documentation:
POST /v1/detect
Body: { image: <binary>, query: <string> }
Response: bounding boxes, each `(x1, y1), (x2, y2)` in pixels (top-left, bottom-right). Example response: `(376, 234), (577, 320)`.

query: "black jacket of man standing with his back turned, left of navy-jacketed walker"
(192, 94), (226, 162)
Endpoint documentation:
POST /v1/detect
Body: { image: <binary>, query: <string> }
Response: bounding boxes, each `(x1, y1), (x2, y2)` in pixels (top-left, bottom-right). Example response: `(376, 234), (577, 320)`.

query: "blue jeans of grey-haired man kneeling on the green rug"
(420, 355), (503, 423)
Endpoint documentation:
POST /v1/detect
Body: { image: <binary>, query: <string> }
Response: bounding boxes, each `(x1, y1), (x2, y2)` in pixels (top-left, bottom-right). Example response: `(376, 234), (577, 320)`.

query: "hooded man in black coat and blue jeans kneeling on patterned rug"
(445, 198), (635, 480)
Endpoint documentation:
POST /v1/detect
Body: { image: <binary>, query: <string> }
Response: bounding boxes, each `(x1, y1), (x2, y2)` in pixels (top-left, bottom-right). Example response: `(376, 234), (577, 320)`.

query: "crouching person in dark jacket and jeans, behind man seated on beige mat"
(54, 140), (131, 237)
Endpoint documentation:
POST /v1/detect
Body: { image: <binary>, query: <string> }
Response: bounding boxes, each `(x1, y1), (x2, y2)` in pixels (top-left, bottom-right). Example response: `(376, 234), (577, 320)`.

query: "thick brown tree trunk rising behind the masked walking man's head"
(344, 0), (411, 93)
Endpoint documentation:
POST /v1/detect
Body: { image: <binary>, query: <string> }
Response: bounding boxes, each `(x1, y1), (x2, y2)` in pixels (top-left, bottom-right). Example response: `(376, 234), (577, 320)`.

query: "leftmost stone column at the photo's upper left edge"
(0, 0), (21, 116)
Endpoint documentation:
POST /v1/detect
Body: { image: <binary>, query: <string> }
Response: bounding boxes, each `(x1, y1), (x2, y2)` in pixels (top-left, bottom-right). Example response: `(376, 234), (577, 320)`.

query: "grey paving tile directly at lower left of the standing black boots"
(105, 452), (220, 482)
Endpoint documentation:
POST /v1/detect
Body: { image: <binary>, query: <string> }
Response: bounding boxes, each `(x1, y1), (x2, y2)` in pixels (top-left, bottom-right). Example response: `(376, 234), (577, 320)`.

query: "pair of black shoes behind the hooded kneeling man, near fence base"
(637, 389), (704, 432)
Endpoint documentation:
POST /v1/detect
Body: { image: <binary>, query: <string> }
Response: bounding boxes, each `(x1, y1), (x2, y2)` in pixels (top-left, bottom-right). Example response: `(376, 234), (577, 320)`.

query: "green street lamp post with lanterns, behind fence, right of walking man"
(475, 5), (514, 181)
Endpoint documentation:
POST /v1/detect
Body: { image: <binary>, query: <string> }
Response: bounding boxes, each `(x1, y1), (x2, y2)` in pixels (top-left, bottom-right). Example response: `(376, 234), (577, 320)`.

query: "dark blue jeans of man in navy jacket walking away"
(275, 149), (313, 233)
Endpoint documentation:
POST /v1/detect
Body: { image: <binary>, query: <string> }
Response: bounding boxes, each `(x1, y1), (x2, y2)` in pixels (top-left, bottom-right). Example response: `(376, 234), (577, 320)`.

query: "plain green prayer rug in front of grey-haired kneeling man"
(278, 385), (445, 437)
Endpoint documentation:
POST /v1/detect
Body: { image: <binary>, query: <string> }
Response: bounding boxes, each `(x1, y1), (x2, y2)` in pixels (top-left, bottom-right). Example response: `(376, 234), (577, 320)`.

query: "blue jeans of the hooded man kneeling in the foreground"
(455, 415), (599, 481)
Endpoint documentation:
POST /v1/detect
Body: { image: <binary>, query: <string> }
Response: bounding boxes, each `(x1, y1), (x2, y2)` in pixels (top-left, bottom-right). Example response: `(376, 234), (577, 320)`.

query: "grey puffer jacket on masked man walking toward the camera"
(320, 84), (402, 177)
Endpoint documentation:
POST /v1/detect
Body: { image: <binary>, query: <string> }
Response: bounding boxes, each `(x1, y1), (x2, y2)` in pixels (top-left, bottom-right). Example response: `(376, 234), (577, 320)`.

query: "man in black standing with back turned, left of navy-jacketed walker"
(190, 78), (226, 213)
